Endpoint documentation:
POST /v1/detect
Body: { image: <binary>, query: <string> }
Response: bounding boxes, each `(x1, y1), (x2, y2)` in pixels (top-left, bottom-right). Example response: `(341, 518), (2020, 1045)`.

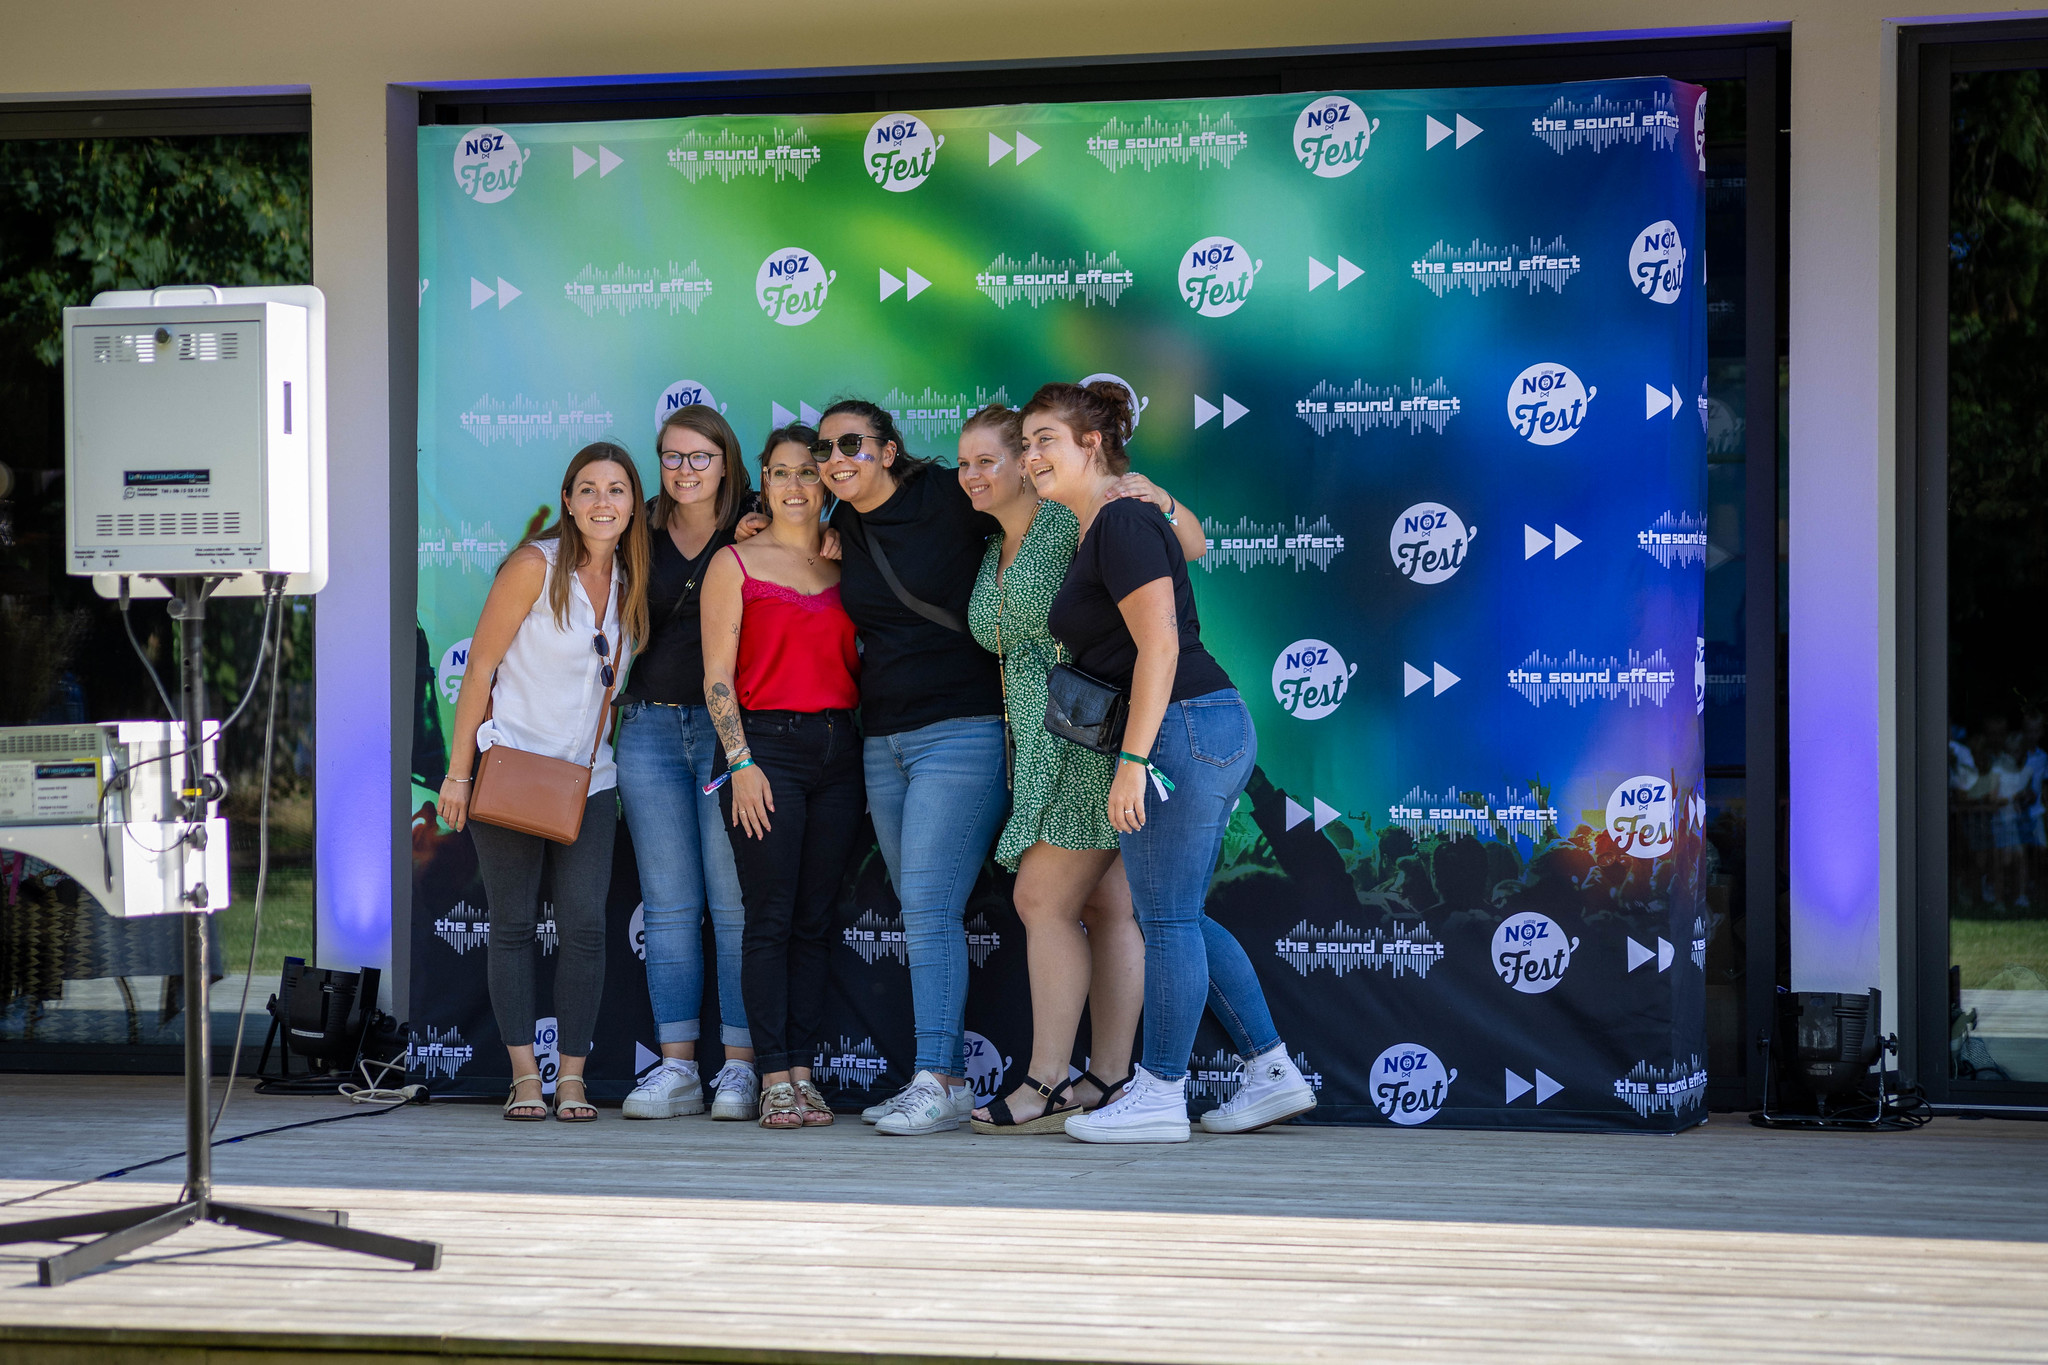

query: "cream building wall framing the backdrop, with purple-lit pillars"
(0, 0), (2017, 1023)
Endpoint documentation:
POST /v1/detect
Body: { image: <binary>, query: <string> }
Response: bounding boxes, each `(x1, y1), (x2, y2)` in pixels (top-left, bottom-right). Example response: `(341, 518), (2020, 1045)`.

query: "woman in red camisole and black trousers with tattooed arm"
(702, 426), (866, 1128)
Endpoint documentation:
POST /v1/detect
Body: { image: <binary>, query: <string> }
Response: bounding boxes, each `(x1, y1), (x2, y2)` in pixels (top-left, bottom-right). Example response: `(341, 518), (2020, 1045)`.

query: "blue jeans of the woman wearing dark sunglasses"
(862, 716), (1010, 1076)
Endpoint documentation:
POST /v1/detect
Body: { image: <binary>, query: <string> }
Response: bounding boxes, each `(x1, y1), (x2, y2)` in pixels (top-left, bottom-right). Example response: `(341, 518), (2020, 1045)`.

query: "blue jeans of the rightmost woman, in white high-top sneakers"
(1116, 688), (1280, 1081)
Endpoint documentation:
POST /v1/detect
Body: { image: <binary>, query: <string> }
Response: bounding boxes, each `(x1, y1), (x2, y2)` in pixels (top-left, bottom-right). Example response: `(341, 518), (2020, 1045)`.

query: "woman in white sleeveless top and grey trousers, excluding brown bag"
(438, 442), (647, 1124)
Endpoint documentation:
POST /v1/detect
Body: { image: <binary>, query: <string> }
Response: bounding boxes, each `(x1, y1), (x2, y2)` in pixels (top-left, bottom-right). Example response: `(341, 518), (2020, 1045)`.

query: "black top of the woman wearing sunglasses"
(831, 467), (1004, 735)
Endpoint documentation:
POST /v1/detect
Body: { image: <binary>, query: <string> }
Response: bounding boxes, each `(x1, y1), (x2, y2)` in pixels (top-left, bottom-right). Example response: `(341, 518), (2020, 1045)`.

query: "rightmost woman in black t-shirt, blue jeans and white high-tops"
(1024, 383), (1315, 1142)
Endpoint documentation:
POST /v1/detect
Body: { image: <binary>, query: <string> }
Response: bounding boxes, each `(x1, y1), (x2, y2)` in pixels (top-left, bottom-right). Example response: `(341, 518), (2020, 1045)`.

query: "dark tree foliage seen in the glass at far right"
(1948, 72), (2048, 731)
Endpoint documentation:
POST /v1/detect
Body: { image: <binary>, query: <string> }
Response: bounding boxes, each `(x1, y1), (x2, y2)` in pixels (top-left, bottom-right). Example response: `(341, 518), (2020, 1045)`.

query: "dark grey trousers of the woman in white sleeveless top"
(469, 788), (618, 1056)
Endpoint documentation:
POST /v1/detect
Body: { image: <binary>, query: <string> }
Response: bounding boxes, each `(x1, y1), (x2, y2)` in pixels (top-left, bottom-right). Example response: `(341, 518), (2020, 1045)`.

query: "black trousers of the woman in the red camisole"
(719, 710), (866, 1074)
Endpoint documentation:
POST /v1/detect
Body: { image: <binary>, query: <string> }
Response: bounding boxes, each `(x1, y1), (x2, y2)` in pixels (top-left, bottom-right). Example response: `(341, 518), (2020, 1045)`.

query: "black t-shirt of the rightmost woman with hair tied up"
(1049, 497), (1231, 702)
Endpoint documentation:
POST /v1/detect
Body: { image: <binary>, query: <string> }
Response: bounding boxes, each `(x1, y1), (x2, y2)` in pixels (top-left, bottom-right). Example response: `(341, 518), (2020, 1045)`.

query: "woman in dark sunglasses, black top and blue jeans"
(813, 399), (1010, 1136)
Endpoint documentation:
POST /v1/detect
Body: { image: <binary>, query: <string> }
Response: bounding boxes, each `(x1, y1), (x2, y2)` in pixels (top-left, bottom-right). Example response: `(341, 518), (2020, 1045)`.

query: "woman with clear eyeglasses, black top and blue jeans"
(616, 403), (760, 1119)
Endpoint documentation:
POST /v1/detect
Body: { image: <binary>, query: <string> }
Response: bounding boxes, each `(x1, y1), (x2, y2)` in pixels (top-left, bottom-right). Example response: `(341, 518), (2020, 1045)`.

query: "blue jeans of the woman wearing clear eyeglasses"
(614, 698), (754, 1048)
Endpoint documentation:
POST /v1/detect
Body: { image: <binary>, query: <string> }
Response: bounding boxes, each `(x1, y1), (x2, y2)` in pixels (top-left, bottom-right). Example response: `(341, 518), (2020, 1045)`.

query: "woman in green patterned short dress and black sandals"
(958, 405), (1206, 1134)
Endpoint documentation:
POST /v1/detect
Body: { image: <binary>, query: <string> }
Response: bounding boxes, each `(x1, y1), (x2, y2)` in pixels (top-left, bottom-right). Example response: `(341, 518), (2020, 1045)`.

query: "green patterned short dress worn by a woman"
(967, 499), (1116, 872)
